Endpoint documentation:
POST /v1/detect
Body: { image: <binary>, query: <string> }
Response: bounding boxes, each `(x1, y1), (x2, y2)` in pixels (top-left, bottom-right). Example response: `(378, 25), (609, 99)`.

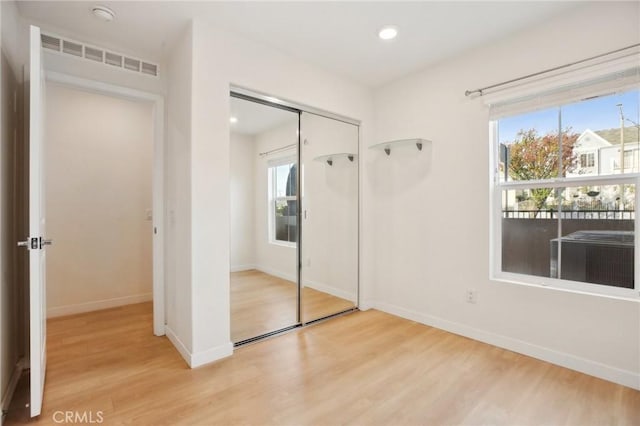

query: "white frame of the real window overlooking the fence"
(489, 120), (640, 301)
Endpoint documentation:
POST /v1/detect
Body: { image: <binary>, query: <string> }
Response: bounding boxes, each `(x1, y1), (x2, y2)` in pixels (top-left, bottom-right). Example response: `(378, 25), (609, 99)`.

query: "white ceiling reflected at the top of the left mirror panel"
(231, 98), (298, 135)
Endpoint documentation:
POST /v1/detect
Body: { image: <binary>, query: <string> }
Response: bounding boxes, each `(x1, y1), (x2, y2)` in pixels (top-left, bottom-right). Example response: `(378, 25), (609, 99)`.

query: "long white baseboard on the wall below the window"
(370, 303), (640, 390)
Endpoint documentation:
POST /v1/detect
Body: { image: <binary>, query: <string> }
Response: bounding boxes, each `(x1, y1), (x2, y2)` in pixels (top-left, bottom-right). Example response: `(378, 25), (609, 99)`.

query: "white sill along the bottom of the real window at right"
(489, 272), (640, 303)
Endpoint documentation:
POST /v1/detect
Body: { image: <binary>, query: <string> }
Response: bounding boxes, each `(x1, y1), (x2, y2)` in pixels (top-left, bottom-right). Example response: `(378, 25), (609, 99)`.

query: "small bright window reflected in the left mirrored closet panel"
(269, 158), (298, 245)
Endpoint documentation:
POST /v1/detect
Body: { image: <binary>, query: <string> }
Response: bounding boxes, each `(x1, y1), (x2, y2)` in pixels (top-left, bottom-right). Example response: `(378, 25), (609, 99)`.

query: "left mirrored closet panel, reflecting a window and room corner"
(230, 97), (298, 343)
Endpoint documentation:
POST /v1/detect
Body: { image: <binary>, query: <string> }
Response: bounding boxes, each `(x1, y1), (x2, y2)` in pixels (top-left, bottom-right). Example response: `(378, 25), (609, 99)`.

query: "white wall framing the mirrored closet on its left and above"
(184, 21), (371, 364)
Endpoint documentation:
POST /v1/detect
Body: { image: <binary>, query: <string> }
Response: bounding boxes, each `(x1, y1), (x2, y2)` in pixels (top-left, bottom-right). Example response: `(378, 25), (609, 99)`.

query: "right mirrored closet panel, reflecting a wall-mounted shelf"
(301, 112), (358, 322)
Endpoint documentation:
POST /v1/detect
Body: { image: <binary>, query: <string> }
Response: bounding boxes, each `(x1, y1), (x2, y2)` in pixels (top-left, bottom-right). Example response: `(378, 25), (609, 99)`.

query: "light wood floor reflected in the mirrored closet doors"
(231, 269), (354, 342)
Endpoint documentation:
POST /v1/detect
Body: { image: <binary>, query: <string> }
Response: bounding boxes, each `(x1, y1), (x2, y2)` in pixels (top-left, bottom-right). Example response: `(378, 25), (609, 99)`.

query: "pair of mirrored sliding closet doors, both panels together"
(230, 93), (358, 345)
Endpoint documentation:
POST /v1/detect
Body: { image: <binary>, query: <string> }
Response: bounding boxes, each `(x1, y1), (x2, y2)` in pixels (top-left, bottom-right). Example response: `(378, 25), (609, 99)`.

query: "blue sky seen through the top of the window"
(498, 90), (640, 143)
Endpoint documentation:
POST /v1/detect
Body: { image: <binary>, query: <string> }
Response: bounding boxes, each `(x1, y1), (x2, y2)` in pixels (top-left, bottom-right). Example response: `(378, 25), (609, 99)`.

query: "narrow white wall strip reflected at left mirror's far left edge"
(230, 133), (256, 271)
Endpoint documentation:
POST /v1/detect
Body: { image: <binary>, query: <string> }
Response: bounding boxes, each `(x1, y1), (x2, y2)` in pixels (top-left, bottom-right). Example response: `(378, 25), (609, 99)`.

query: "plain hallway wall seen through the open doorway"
(45, 84), (153, 317)
